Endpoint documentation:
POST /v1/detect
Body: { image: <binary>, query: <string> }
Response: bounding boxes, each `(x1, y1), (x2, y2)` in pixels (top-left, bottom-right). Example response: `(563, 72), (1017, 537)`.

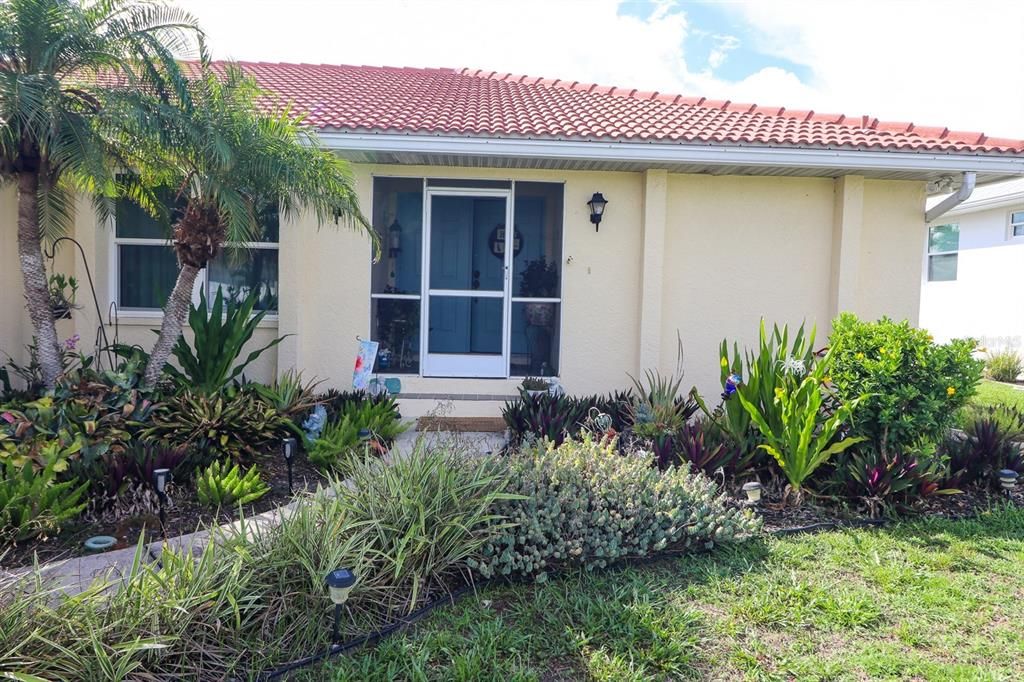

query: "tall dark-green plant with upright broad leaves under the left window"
(165, 289), (285, 395)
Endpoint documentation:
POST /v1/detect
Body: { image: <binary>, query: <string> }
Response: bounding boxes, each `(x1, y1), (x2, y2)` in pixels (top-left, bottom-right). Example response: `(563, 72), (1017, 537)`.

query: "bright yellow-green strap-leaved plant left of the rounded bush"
(736, 351), (863, 506)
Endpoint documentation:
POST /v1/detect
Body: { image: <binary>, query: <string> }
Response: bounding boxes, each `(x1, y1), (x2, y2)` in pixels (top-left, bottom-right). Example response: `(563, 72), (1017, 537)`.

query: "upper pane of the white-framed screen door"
(430, 196), (506, 291)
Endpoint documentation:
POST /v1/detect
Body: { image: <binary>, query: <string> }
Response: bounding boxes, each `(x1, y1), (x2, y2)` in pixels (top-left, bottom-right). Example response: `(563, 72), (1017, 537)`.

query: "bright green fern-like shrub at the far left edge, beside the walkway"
(0, 458), (88, 542)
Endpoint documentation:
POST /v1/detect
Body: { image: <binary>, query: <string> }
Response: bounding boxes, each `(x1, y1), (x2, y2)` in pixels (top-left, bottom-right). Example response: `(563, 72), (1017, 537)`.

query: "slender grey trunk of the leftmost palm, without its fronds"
(17, 172), (63, 389)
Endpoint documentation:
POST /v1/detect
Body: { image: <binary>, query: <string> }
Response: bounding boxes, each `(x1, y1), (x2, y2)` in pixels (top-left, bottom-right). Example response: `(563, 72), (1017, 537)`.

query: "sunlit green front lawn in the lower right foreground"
(308, 509), (1024, 682)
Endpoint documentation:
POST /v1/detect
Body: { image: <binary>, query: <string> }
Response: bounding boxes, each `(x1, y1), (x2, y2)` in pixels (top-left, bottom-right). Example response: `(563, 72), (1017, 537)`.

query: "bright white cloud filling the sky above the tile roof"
(178, 0), (1024, 137)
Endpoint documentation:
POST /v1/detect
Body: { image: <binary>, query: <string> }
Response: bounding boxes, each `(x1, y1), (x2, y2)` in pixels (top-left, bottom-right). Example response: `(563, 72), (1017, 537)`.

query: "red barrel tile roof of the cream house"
(207, 61), (1024, 154)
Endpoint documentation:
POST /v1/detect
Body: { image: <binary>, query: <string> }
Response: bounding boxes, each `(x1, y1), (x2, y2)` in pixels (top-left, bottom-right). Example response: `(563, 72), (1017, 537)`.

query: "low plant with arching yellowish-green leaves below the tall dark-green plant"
(142, 390), (285, 465)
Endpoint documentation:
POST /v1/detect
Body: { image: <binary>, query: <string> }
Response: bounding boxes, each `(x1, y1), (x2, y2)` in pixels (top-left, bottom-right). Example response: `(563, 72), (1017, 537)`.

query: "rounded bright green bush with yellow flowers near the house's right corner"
(829, 312), (983, 454)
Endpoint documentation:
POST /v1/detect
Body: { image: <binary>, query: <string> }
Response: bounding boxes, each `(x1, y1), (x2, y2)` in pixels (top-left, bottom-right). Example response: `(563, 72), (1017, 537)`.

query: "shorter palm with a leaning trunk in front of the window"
(126, 65), (376, 385)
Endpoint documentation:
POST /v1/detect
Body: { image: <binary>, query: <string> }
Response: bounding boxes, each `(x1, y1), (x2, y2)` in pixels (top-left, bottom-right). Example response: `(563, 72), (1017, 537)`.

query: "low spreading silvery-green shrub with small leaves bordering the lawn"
(472, 435), (759, 580)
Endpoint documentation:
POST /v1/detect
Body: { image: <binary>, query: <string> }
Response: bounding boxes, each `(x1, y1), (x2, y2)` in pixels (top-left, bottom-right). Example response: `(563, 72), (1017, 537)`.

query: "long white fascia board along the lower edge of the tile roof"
(318, 130), (1024, 176)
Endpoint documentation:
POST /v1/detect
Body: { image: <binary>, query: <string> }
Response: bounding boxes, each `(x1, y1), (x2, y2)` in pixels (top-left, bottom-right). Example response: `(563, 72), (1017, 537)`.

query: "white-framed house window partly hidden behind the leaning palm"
(114, 193), (280, 313)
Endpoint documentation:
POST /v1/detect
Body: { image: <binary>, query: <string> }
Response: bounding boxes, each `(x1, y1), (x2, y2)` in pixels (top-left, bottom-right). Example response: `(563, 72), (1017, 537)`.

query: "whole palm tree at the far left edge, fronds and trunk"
(0, 0), (202, 388)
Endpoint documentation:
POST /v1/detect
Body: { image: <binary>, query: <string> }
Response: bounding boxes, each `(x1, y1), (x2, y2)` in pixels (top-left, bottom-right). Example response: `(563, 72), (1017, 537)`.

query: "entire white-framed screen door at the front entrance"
(420, 188), (512, 378)
